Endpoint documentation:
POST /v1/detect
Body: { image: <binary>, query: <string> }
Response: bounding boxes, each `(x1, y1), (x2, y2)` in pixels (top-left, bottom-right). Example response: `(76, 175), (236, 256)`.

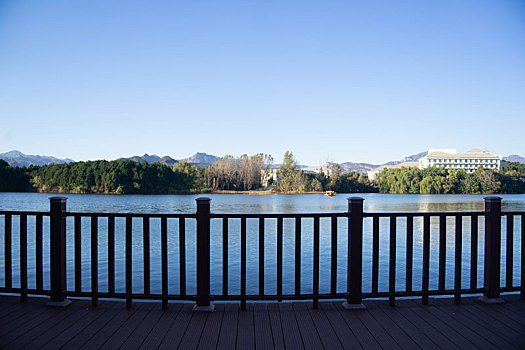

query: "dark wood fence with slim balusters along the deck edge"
(0, 197), (525, 308)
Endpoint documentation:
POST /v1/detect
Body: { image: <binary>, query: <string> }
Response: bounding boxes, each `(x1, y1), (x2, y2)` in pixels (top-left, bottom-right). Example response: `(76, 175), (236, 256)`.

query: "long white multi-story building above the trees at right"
(419, 148), (505, 173)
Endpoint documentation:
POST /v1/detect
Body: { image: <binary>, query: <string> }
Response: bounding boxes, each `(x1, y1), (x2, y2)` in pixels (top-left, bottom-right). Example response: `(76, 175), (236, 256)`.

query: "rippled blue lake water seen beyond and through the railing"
(0, 193), (525, 294)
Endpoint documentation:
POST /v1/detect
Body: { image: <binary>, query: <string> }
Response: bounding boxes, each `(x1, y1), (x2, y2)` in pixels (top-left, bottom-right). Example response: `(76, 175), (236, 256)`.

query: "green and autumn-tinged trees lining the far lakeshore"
(0, 151), (525, 194)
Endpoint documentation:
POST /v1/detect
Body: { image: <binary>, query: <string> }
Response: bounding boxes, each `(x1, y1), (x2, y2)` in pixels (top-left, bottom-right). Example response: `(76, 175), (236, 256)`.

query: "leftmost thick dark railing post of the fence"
(47, 197), (71, 307)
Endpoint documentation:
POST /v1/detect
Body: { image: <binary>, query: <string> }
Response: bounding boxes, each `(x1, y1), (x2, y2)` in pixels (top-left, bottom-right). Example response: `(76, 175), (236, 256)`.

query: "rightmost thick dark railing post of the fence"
(481, 196), (503, 304)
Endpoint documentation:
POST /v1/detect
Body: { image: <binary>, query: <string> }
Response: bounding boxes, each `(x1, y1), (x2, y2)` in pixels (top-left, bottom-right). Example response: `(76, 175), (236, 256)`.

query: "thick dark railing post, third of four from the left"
(343, 197), (366, 309)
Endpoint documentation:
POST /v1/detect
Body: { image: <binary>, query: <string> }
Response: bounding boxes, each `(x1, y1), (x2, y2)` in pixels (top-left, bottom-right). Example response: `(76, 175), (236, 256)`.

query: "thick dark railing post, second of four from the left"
(193, 197), (215, 312)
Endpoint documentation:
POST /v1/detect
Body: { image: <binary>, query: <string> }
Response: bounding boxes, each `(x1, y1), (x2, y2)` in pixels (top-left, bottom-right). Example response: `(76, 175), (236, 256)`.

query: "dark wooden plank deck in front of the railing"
(0, 295), (525, 349)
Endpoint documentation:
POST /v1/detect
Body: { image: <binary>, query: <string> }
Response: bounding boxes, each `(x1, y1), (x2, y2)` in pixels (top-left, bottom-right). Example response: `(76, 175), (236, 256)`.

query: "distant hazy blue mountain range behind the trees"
(0, 151), (525, 174)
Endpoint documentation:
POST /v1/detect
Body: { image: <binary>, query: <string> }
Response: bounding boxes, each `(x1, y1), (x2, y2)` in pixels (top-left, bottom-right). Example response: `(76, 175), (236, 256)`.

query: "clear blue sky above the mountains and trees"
(0, 0), (525, 164)
